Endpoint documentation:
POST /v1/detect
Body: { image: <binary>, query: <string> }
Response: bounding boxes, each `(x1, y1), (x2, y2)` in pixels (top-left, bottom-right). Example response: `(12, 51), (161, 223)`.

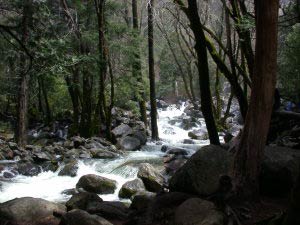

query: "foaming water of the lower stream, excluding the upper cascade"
(0, 148), (162, 202)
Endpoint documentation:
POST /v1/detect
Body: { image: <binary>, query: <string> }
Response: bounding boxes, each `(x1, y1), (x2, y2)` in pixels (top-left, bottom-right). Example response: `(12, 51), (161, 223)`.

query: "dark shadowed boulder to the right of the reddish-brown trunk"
(260, 147), (300, 196)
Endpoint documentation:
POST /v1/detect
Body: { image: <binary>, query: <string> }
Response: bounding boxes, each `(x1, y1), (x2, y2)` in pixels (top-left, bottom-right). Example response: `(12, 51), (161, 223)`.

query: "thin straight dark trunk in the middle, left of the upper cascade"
(148, 0), (158, 140)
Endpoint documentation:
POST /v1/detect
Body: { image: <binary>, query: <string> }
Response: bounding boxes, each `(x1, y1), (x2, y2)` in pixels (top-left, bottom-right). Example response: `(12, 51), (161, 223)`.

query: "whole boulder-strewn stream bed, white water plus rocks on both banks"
(0, 104), (300, 225)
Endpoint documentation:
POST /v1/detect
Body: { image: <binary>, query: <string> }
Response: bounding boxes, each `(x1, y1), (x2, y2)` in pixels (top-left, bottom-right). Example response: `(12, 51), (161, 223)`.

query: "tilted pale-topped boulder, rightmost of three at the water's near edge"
(137, 163), (164, 192)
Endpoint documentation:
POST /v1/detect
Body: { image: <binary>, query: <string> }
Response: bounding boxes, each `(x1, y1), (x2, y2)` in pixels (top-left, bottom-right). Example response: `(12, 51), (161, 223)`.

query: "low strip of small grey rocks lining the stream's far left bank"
(0, 131), (145, 178)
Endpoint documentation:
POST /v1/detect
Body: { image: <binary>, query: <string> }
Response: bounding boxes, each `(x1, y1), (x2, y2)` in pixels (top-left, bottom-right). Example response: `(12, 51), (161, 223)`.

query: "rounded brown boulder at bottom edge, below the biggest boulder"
(175, 198), (225, 225)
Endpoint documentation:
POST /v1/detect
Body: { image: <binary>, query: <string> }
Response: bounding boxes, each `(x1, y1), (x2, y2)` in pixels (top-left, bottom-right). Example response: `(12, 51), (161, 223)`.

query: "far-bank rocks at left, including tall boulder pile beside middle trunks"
(0, 107), (147, 178)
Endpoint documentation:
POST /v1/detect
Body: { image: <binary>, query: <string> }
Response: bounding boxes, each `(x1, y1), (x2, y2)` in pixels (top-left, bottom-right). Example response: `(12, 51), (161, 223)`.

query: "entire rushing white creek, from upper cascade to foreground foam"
(0, 104), (208, 202)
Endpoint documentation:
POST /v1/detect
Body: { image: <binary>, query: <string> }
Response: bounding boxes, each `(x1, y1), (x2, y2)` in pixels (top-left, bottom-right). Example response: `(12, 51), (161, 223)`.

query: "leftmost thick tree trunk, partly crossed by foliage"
(15, 0), (32, 147)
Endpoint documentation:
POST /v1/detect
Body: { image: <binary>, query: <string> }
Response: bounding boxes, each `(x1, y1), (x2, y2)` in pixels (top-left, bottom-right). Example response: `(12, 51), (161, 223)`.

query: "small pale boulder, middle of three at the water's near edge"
(119, 178), (146, 198)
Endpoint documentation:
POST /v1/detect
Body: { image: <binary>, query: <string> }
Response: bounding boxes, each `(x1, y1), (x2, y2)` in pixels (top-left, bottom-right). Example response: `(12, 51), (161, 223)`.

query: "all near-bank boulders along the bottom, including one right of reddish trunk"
(0, 145), (300, 225)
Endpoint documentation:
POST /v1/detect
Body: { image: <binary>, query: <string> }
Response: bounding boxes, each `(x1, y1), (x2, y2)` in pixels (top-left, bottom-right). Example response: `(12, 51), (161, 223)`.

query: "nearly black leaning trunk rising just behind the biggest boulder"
(175, 0), (220, 145)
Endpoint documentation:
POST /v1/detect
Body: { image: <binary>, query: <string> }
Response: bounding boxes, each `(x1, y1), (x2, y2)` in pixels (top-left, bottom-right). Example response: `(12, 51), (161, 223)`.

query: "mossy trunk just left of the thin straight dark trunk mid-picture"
(132, 0), (147, 126)
